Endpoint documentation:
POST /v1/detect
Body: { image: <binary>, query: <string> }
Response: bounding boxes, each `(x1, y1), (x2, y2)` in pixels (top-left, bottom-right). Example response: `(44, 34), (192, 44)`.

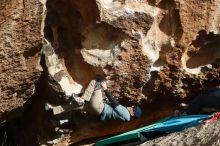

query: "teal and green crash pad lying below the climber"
(95, 115), (211, 146)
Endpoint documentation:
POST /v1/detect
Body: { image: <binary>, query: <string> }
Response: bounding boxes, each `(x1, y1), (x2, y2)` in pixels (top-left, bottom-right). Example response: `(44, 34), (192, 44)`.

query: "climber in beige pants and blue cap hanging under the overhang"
(44, 77), (142, 121)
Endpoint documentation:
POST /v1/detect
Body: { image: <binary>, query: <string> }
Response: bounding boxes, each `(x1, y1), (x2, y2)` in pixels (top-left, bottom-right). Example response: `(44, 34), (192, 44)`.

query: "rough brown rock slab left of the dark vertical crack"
(0, 0), (44, 117)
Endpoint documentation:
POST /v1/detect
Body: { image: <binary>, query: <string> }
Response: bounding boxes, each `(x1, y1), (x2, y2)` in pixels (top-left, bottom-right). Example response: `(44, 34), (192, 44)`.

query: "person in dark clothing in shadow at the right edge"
(174, 88), (220, 115)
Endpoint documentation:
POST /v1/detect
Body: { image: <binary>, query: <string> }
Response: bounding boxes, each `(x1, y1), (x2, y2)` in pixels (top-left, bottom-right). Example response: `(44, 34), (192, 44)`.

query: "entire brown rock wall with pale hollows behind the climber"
(0, 0), (220, 144)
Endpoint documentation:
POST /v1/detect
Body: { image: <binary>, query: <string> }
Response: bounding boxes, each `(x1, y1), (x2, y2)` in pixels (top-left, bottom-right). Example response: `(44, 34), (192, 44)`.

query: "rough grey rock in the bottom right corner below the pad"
(141, 120), (220, 146)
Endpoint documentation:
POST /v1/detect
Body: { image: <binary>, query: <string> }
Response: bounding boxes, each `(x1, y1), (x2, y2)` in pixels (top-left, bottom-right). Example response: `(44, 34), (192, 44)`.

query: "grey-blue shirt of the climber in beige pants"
(100, 103), (131, 121)
